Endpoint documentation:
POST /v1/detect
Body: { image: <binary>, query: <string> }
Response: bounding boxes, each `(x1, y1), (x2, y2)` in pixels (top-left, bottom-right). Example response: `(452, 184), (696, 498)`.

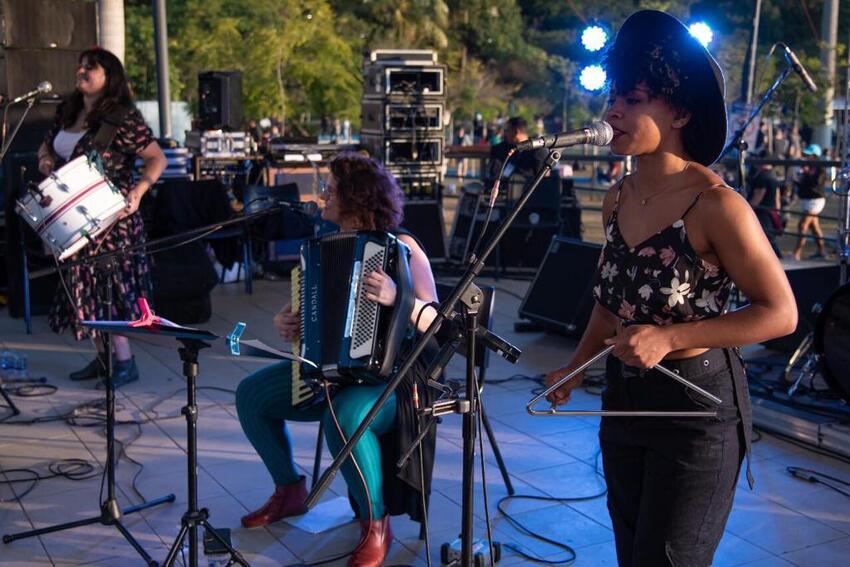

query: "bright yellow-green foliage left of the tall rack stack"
(122, 0), (362, 132)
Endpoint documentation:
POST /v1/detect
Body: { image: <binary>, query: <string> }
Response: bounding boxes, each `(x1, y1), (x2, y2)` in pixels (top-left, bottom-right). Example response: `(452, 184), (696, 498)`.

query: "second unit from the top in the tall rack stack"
(361, 99), (443, 134)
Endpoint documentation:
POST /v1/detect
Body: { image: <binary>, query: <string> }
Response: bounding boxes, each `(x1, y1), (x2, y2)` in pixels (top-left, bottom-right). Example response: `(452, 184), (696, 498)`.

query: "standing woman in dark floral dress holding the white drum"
(38, 47), (167, 386)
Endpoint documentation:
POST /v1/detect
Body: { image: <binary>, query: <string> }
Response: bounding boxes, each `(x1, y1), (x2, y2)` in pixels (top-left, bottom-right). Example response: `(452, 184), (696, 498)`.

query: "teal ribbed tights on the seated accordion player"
(236, 361), (396, 518)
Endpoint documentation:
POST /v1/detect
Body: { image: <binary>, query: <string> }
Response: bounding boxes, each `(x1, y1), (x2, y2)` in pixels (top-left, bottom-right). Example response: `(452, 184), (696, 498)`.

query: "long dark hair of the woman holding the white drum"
(62, 47), (133, 128)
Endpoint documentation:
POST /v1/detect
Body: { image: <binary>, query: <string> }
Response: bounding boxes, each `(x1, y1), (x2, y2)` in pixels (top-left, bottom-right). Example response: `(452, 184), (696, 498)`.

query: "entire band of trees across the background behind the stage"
(126, 0), (850, 133)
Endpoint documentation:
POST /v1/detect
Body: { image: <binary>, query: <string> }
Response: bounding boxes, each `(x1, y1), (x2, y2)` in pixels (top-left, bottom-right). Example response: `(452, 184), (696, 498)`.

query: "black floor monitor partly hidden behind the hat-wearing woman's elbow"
(763, 264), (839, 352)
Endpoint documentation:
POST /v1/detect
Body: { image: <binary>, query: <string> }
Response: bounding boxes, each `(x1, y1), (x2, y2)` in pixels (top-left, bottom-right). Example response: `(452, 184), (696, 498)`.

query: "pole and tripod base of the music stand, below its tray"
(162, 338), (248, 567)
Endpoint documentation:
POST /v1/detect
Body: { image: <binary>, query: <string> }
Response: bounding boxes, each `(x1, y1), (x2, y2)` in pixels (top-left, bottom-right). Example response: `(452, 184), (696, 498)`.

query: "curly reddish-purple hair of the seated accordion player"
(329, 152), (404, 231)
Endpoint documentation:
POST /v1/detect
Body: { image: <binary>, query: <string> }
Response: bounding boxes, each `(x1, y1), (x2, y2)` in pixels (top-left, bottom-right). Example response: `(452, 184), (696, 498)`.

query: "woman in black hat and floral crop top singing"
(547, 11), (797, 567)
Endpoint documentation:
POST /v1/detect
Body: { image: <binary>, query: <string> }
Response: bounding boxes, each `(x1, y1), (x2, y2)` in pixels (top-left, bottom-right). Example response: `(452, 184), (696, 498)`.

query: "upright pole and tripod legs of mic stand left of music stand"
(3, 256), (175, 567)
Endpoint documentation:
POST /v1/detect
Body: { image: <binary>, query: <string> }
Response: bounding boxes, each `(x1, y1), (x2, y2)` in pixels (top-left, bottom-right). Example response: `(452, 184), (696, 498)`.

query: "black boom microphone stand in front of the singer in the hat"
(305, 149), (561, 567)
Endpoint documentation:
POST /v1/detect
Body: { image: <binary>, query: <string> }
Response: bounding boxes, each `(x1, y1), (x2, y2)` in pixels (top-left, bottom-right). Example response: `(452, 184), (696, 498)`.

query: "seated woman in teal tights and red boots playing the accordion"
(236, 154), (437, 567)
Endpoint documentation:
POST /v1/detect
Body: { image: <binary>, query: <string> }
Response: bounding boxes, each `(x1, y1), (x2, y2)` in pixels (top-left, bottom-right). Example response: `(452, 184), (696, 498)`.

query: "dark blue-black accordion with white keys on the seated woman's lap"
(292, 231), (415, 406)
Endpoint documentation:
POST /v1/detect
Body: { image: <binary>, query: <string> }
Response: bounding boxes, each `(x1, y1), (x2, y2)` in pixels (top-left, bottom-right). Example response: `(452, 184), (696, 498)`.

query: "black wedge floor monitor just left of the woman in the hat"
(519, 236), (602, 337)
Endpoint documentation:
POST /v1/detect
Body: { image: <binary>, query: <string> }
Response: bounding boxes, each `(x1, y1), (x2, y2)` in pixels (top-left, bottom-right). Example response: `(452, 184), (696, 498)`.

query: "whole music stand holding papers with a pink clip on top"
(82, 318), (248, 567)
